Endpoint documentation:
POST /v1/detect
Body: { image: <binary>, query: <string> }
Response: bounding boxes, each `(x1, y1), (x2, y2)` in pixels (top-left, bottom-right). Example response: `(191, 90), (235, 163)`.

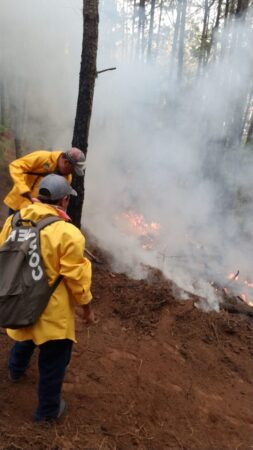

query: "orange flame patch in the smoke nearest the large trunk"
(115, 209), (161, 250)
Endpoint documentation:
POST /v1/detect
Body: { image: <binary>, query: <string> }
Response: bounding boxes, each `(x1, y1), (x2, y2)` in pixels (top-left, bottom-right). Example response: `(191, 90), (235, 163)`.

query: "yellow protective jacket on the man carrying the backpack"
(0, 203), (92, 345)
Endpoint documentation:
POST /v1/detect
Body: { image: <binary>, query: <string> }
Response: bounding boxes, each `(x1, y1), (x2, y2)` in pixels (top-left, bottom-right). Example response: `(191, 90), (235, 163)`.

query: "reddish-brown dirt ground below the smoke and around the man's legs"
(0, 147), (253, 450)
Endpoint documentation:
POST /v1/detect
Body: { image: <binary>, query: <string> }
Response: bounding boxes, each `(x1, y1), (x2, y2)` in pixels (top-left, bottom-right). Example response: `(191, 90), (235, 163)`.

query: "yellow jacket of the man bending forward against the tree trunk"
(4, 150), (72, 211)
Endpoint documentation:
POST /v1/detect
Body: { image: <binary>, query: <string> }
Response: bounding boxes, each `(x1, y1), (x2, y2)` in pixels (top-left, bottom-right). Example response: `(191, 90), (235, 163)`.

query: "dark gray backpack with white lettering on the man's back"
(0, 212), (63, 329)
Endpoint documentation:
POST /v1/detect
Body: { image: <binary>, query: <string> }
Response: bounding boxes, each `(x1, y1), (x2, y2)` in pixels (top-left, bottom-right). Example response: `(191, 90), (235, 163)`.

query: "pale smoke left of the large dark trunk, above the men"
(0, 0), (82, 149)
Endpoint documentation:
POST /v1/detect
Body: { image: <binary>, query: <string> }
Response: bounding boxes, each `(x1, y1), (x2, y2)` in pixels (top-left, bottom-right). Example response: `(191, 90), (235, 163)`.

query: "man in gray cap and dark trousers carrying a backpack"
(0, 174), (94, 421)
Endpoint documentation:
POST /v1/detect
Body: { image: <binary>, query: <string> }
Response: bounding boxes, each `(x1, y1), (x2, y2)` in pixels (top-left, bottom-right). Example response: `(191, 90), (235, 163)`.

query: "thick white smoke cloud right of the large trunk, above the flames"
(85, 2), (253, 308)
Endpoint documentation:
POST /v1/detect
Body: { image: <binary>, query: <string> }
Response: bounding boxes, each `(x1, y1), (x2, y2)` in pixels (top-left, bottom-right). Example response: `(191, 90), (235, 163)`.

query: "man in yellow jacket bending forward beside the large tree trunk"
(4, 147), (85, 214)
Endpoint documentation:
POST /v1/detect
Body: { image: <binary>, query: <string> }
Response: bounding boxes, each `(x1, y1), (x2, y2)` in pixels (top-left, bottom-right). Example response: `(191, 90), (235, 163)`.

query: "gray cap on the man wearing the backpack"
(39, 173), (77, 200)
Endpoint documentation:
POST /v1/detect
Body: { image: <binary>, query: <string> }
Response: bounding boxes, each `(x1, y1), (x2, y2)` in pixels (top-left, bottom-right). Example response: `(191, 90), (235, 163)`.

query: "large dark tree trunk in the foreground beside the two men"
(68, 0), (99, 228)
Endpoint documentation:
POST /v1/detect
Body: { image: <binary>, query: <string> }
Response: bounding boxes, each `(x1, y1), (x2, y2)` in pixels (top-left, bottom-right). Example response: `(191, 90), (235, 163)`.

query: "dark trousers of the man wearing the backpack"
(8, 339), (73, 420)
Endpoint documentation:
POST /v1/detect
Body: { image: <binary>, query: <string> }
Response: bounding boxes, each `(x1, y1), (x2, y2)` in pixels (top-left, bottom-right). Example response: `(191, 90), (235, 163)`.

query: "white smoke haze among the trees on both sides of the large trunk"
(0, 0), (253, 309)
